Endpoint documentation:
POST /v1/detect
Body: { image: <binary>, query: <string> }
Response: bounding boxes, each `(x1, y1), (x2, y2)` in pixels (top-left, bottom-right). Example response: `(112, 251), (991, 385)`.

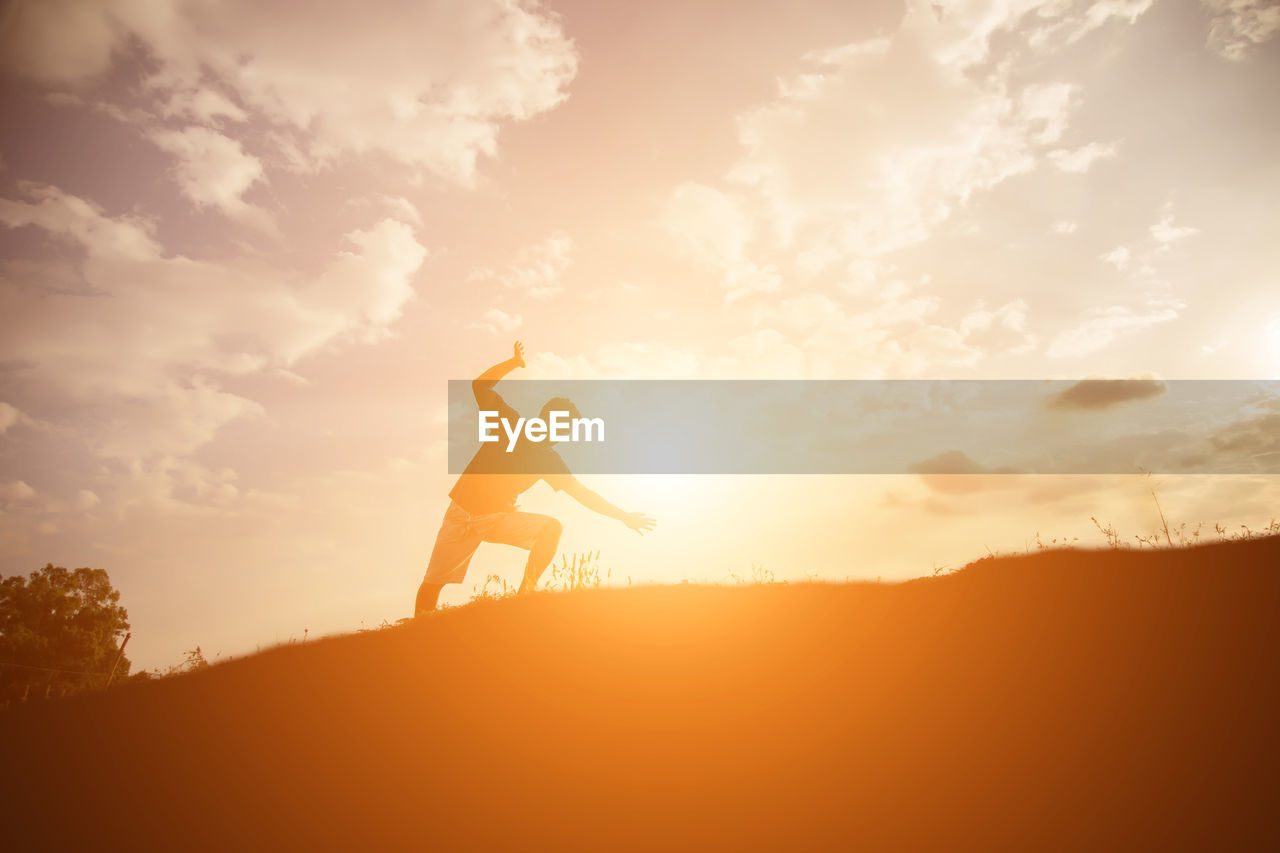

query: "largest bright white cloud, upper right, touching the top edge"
(722, 3), (1102, 270)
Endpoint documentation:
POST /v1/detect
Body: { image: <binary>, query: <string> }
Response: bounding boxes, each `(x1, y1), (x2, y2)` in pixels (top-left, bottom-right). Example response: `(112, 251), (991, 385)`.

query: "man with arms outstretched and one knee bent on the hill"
(413, 341), (654, 615)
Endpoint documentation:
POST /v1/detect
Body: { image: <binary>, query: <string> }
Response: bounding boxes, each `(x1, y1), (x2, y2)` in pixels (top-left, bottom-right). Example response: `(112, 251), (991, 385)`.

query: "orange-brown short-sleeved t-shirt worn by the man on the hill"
(449, 393), (570, 515)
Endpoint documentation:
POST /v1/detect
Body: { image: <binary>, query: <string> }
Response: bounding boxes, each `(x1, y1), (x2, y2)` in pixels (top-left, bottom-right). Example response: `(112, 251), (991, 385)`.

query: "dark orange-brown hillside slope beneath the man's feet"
(0, 538), (1280, 850)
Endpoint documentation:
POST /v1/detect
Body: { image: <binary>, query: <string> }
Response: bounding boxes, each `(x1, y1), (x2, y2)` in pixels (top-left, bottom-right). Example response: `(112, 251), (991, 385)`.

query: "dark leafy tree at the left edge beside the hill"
(0, 564), (129, 701)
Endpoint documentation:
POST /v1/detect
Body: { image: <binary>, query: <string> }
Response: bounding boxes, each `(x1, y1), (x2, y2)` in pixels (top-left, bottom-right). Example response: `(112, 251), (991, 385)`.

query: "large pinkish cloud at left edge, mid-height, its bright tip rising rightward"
(0, 184), (426, 460)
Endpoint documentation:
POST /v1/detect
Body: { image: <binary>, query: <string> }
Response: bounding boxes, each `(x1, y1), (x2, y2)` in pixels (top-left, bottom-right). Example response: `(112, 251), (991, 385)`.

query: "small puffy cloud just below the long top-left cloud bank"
(148, 127), (271, 229)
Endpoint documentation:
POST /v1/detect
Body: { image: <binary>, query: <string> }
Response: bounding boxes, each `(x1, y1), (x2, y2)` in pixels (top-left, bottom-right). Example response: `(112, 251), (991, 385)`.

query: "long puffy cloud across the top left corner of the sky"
(0, 0), (577, 184)
